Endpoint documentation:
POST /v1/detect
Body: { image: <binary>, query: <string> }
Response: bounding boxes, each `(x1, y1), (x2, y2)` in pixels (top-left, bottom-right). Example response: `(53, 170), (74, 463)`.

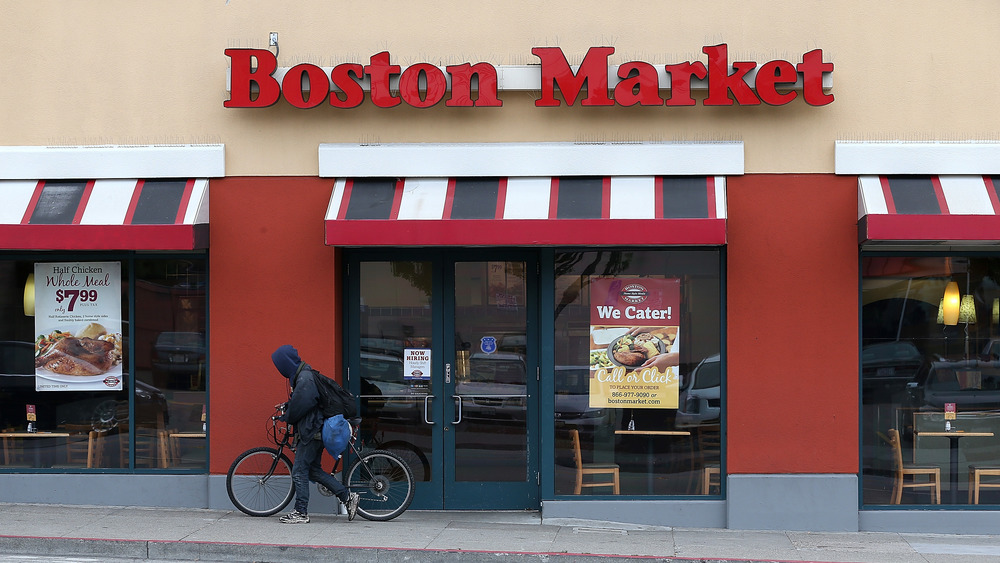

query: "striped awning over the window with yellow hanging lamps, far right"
(858, 175), (1000, 244)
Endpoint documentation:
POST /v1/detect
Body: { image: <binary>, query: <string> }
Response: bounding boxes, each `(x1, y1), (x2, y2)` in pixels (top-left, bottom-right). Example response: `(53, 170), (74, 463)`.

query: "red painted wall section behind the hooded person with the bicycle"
(209, 177), (340, 474)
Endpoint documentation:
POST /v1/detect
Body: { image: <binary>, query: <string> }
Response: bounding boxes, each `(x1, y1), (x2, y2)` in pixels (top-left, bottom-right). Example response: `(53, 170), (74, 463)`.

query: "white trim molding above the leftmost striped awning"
(0, 144), (226, 180)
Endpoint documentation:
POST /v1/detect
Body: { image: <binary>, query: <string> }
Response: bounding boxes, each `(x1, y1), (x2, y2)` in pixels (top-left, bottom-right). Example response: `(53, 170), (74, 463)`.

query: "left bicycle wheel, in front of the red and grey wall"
(226, 447), (295, 516)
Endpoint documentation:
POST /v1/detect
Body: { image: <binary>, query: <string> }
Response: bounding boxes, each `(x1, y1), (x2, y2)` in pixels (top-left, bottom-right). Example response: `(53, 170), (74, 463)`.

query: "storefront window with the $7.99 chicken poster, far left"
(0, 255), (207, 471)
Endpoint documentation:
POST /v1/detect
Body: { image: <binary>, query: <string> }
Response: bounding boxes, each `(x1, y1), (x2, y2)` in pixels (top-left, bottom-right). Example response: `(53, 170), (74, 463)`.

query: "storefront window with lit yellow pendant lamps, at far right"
(861, 255), (1000, 505)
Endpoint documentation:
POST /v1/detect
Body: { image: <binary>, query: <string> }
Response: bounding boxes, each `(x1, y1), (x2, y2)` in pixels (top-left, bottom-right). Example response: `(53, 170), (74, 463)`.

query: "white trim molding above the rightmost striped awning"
(835, 141), (1000, 176)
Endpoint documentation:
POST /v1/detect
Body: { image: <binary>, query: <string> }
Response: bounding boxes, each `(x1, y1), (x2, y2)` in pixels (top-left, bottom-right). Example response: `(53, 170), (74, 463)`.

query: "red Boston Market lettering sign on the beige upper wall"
(223, 43), (833, 109)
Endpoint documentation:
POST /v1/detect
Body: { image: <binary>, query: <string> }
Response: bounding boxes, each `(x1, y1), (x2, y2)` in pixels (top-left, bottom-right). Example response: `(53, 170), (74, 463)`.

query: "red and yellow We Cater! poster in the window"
(590, 278), (681, 409)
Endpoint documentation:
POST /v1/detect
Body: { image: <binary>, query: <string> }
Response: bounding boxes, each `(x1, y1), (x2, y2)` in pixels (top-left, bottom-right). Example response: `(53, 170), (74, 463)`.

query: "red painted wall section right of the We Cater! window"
(726, 175), (858, 474)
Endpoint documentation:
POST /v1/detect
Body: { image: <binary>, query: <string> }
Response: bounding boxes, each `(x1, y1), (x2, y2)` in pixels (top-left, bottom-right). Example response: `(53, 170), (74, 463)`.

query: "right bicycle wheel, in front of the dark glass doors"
(345, 450), (413, 521)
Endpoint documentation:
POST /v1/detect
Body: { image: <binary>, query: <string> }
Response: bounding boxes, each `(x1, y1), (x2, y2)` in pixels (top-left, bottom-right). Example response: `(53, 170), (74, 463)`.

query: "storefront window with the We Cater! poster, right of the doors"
(554, 249), (724, 496)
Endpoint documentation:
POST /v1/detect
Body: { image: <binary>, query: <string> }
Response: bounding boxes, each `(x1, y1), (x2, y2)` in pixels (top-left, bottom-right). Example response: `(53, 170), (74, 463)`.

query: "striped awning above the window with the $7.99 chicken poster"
(0, 179), (208, 250)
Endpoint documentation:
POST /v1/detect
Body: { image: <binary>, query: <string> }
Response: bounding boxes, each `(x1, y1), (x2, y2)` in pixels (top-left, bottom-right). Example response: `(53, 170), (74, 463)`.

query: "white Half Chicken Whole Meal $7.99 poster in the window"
(35, 262), (124, 391)
